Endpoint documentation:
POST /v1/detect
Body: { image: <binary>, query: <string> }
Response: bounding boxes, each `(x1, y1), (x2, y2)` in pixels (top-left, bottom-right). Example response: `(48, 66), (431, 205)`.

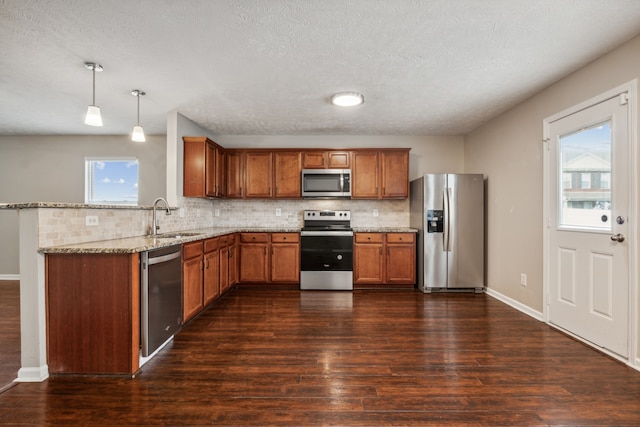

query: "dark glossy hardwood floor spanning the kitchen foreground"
(0, 288), (640, 426)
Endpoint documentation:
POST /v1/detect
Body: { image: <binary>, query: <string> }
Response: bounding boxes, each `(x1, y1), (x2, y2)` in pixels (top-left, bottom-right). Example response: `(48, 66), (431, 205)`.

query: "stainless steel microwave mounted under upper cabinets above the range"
(302, 169), (351, 199)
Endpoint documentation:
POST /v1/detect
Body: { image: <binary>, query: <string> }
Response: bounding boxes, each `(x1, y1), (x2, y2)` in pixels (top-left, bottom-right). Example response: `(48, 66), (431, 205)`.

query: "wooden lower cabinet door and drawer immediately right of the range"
(353, 233), (384, 284)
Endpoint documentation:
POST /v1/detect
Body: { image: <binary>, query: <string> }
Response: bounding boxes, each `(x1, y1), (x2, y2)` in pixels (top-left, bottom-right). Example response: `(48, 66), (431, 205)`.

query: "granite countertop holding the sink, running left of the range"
(38, 227), (300, 254)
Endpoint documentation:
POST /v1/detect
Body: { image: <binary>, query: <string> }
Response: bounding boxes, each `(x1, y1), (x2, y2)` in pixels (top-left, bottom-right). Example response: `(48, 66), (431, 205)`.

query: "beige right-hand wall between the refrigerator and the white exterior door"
(464, 37), (640, 354)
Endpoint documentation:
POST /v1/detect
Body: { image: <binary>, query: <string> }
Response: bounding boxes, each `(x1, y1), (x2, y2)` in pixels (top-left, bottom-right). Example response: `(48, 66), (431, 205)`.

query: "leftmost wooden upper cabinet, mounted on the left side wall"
(182, 136), (225, 197)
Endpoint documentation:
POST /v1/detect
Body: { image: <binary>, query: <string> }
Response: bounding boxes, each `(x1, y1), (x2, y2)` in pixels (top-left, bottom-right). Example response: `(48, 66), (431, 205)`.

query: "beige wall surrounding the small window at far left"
(0, 135), (166, 275)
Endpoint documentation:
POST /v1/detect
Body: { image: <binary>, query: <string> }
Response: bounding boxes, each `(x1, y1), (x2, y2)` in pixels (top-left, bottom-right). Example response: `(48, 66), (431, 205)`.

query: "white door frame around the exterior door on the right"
(542, 79), (640, 370)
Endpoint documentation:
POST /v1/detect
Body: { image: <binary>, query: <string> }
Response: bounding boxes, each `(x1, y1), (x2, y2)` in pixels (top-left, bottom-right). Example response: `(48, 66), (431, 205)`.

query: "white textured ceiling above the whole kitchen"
(0, 0), (640, 135)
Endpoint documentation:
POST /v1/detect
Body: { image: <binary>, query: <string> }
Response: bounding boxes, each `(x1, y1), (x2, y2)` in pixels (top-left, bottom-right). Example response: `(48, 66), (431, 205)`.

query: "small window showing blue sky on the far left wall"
(84, 157), (138, 205)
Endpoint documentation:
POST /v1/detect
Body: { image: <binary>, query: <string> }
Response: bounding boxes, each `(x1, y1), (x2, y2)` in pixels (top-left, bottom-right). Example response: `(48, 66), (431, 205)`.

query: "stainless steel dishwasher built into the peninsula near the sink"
(140, 245), (182, 357)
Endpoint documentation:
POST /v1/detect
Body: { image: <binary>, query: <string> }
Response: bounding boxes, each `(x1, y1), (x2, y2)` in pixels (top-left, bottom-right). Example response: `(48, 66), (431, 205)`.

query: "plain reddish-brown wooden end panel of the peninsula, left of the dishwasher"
(45, 253), (140, 376)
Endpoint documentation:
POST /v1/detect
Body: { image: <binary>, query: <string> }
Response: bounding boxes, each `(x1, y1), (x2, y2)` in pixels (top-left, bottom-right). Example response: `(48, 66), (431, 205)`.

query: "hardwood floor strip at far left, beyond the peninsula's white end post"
(0, 280), (20, 393)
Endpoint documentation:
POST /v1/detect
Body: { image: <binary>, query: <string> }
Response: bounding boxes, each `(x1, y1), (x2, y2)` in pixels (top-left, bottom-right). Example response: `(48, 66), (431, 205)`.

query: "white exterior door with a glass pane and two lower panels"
(545, 94), (631, 358)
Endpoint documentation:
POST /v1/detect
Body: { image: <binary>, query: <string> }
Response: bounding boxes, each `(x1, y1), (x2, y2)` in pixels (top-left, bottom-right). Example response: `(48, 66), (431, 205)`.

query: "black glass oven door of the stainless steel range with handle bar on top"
(300, 231), (353, 271)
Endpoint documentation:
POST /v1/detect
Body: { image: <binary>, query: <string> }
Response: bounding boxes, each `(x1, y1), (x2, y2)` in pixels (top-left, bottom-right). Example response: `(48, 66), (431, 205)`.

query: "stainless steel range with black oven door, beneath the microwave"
(300, 211), (353, 291)
